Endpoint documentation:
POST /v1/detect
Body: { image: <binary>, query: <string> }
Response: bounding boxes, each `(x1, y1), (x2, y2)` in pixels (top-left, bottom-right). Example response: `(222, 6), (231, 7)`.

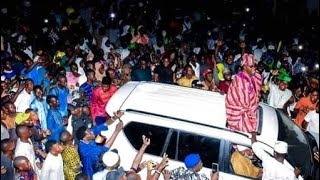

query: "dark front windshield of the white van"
(276, 110), (312, 177)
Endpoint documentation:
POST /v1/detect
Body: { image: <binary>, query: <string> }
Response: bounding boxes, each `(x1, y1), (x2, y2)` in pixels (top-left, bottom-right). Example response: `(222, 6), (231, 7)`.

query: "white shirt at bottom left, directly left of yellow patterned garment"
(39, 153), (64, 180)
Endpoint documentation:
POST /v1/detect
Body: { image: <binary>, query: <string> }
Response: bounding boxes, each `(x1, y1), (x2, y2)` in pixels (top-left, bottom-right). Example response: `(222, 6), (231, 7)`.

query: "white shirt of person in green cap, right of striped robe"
(268, 83), (292, 109)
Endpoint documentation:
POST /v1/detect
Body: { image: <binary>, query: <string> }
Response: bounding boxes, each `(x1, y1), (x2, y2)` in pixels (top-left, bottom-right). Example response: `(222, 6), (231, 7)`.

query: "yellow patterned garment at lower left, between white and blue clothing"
(62, 145), (80, 180)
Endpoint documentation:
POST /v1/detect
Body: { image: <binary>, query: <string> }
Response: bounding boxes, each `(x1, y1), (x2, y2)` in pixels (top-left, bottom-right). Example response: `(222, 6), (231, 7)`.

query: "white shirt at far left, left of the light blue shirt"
(14, 89), (35, 113)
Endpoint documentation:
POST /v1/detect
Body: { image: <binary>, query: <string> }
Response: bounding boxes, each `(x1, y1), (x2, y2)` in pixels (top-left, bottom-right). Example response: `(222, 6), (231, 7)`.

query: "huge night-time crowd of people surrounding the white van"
(1, 0), (319, 180)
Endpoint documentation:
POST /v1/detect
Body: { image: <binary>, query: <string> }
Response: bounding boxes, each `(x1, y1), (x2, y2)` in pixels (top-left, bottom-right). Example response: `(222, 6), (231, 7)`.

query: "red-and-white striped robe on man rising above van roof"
(226, 71), (262, 132)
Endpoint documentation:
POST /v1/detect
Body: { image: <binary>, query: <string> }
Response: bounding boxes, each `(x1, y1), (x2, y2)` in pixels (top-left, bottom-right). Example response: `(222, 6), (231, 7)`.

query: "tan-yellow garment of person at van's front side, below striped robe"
(230, 151), (261, 178)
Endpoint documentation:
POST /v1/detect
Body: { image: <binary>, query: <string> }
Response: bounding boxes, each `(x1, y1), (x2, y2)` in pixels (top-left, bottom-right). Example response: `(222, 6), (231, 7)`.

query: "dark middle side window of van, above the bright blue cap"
(167, 131), (220, 168)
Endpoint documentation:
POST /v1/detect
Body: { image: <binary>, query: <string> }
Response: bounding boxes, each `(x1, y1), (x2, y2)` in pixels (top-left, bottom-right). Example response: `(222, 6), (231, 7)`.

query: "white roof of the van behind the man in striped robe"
(106, 81), (226, 128)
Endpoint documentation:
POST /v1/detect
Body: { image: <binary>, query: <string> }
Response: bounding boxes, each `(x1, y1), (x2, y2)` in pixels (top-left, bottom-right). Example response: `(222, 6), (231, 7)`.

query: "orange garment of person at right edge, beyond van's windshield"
(294, 96), (316, 127)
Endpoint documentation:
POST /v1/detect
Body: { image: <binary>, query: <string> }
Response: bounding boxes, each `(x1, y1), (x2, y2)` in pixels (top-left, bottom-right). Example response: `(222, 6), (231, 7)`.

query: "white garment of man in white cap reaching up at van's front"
(252, 142), (298, 180)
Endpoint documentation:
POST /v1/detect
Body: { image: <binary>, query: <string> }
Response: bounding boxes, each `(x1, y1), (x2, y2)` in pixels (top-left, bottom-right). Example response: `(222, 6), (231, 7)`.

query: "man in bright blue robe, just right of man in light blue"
(47, 95), (68, 142)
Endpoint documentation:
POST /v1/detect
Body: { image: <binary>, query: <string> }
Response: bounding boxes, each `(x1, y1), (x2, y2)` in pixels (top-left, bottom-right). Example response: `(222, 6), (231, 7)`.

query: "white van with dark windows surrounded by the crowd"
(106, 82), (314, 180)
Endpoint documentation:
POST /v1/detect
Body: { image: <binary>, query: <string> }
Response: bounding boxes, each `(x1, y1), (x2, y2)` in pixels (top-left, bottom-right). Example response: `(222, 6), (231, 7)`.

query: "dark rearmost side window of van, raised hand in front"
(123, 122), (169, 156)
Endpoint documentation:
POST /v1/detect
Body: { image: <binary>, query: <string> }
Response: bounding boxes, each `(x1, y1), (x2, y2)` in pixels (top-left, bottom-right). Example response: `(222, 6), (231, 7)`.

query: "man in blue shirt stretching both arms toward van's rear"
(76, 121), (123, 179)
